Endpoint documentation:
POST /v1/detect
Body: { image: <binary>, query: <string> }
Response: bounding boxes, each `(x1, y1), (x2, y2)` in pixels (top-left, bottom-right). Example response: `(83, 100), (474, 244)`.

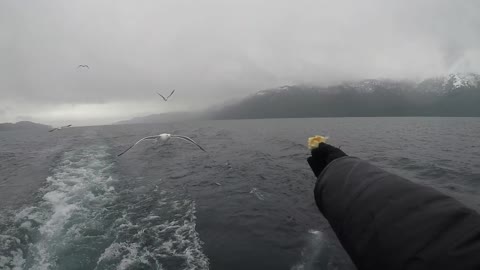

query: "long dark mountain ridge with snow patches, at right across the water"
(210, 73), (480, 119)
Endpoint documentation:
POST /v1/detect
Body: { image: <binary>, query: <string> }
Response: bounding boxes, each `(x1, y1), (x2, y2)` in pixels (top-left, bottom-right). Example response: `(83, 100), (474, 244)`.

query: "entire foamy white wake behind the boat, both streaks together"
(0, 146), (209, 270)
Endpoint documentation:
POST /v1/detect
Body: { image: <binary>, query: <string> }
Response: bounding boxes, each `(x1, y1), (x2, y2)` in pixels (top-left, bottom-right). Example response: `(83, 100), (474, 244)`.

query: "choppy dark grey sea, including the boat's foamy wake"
(0, 118), (480, 269)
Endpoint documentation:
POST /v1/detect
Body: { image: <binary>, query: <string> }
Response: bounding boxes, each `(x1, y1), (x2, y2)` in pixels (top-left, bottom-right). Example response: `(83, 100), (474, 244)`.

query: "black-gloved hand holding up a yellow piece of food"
(307, 143), (347, 177)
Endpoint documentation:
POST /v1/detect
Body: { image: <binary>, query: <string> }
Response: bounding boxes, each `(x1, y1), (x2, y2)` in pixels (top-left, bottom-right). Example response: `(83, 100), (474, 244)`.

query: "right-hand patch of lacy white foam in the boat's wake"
(97, 200), (209, 270)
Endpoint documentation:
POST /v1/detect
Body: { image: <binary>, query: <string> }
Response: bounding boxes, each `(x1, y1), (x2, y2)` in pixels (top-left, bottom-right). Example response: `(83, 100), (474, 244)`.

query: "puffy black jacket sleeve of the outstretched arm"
(315, 157), (480, 270)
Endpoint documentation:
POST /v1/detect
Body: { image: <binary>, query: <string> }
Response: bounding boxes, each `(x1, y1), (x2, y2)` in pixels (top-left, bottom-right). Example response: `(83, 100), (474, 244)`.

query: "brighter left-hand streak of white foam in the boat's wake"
(31, 146), (116, 270)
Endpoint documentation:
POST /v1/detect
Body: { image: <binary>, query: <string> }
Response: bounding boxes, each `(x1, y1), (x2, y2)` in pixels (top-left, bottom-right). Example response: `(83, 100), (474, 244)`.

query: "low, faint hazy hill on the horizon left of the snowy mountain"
(114, 112), (203, 125)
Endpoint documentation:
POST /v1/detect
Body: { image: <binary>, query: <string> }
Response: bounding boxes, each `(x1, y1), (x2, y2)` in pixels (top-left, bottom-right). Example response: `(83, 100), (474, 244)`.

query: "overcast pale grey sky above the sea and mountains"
(0, 0), (480, 125)
